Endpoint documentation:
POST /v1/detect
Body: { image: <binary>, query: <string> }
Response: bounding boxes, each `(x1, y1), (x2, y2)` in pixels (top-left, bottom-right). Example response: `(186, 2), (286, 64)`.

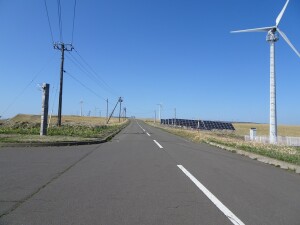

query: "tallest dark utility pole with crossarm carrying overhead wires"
(53, 42), (74, 127)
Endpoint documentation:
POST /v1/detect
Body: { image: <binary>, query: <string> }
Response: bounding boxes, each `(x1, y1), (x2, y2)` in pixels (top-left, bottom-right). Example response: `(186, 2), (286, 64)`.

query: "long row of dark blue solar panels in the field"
(160, 119), (235, 130)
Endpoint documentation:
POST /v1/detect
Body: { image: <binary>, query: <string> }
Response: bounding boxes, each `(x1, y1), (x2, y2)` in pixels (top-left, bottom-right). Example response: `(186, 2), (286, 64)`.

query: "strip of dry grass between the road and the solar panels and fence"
(147, 121), (300, 165)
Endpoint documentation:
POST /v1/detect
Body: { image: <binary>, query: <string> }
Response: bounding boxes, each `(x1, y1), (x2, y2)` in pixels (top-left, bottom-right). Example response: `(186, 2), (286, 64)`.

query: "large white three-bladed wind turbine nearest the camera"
(231, 0), (300, 144)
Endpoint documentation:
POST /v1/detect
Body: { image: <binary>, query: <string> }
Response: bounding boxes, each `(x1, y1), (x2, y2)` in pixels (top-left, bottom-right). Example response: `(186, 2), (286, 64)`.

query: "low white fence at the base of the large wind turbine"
(245, 135), (300, 146)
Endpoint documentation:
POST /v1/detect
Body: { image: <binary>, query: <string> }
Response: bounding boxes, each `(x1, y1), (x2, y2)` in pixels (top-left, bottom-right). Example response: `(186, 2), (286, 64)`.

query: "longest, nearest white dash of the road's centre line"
(177, 165), (245, 225)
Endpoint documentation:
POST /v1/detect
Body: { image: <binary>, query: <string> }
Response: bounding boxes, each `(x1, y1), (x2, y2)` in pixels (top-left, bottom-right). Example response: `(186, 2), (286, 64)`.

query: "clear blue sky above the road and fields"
(0, 0), (300, 124)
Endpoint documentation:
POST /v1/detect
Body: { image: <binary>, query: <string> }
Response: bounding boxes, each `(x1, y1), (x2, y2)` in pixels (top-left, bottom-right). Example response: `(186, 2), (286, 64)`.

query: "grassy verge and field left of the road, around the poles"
(0, 114), (128, 143)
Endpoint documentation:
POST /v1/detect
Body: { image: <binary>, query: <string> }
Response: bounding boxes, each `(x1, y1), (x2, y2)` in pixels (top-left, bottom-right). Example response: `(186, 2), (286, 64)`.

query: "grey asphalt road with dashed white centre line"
(0, 120), (300, 225)
